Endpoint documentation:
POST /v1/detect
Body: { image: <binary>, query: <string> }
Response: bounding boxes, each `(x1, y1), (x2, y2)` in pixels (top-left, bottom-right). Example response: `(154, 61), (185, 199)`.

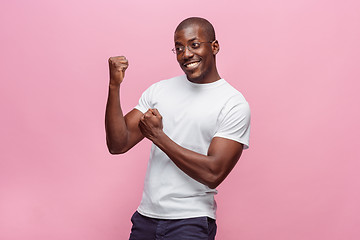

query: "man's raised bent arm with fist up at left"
(105, 56), (144, 154)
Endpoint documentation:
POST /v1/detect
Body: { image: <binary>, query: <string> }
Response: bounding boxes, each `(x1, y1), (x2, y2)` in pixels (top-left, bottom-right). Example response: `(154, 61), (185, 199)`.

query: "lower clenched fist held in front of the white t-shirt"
(139, 108), (163, 141)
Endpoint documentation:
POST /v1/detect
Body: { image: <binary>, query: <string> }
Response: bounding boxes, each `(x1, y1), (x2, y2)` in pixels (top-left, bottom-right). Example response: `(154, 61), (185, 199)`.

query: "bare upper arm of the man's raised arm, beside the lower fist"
(124, 108), (144, 151)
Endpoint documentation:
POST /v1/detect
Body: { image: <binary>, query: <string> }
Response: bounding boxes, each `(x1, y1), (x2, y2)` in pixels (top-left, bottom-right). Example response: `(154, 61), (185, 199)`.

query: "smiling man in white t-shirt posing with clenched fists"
(105, 17), (250, 240)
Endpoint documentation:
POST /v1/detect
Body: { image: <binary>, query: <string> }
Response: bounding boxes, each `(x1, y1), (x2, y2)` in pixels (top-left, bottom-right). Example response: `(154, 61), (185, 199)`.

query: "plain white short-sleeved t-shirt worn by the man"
(135, 75), (250, 219)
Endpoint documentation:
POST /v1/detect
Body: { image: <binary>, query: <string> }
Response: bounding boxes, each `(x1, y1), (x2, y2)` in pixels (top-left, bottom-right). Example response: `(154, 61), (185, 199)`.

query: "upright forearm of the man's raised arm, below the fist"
(105, 85), (128, 154)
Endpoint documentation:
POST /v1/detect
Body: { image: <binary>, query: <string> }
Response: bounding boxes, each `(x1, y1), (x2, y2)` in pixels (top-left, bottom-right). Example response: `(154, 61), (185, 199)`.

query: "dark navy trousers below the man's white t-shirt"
(129, 211), (217, 240)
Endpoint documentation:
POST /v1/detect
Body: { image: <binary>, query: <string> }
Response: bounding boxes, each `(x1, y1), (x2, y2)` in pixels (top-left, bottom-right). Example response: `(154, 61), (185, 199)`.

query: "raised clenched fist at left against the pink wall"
(109, 56), (129, 85)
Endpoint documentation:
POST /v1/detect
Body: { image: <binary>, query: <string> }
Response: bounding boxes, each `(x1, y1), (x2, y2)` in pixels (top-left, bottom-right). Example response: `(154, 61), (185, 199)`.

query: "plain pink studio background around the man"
(0, 0), (360, 240)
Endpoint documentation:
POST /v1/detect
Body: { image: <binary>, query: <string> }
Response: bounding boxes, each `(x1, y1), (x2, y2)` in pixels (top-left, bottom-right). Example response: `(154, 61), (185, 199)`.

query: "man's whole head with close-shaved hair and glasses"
(174, 17), (220, 83)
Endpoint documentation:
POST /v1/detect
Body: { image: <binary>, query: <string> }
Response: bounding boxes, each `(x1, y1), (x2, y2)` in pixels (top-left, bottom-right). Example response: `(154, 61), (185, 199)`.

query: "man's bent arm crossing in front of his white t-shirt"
(139, 109), (243, 188)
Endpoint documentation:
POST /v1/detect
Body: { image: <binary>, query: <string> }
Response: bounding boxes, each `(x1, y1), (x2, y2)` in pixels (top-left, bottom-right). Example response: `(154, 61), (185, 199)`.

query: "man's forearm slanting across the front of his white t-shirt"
(151, 131), (227, 188)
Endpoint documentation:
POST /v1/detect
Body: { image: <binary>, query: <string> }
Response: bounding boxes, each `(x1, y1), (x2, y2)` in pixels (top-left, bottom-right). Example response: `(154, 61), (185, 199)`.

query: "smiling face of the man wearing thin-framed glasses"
(174, 25), (219, 83)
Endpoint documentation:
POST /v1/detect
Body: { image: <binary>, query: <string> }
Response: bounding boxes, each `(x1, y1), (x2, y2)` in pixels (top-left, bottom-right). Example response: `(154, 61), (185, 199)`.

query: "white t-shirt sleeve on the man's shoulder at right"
(214, 98), (250, 149)
